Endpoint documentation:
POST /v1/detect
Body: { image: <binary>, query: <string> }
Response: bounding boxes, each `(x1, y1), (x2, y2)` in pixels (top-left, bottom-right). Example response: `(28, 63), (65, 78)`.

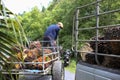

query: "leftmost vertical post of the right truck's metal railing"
(75, 9), (79, 58)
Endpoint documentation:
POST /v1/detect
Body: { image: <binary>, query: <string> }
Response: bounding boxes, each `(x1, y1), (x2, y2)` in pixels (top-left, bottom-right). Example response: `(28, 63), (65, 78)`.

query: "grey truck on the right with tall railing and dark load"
(73, 0), (120, 80)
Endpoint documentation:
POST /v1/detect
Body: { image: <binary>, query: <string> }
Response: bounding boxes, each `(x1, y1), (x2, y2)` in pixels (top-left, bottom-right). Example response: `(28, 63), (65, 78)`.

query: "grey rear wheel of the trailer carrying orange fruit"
(52, 61), (64, 80)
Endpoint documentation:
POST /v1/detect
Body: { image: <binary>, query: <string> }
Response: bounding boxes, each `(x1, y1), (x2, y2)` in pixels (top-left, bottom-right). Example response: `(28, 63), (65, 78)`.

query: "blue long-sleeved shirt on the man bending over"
(44, 24), (60, 40)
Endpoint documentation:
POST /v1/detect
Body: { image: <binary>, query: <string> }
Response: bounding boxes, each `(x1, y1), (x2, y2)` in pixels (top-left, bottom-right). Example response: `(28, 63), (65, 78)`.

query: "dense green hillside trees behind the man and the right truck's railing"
(22, 0), (120, 48)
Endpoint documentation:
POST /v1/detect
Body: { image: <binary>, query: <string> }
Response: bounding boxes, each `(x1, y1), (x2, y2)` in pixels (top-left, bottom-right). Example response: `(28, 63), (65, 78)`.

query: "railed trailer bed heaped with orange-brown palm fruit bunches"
(3, 41), (59, 75)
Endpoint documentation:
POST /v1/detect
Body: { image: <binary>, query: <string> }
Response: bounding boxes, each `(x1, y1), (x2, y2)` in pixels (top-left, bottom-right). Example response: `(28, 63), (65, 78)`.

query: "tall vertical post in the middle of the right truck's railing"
(95, 0), (99, 65)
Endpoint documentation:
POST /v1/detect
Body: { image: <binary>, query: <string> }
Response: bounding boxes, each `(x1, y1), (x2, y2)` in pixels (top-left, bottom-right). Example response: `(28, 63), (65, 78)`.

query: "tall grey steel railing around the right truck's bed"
(73, 0), (120, 64)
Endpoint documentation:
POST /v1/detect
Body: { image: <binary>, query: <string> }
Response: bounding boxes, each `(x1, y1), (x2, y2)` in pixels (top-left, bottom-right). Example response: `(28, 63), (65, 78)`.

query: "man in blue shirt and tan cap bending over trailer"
(43, 22), (63, 51)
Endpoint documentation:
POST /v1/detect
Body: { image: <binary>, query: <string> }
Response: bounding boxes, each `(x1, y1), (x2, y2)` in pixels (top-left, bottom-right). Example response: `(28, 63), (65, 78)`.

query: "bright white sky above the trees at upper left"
(2, 0), (52, 14)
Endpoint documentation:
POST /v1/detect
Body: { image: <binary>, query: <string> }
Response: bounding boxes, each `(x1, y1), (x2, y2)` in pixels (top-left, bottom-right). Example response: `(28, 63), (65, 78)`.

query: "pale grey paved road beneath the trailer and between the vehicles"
(19, 70), (75, 80)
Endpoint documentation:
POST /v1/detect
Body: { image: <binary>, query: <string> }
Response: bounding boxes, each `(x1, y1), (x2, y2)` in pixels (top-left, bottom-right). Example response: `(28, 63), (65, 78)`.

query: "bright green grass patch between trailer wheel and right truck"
(65, 58), (76, 73)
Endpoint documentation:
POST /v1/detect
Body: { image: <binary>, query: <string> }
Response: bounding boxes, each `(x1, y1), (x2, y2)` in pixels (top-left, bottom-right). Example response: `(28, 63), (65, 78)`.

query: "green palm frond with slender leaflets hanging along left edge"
(0, 4), (26, 80)
